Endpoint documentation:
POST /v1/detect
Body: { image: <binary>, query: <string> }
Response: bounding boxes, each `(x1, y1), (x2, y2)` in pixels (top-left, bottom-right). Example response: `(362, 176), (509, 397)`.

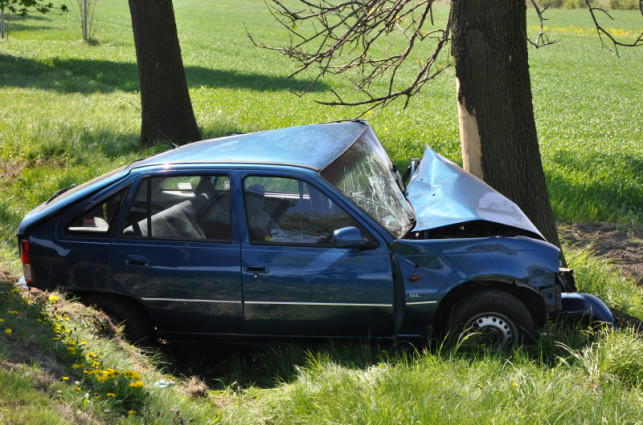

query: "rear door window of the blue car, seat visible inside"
(122, 175), (232, 242)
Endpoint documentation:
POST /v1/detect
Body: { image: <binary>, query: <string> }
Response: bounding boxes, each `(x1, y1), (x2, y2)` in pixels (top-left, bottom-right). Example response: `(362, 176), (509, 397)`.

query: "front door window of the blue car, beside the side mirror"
(243, 176), (360, 246)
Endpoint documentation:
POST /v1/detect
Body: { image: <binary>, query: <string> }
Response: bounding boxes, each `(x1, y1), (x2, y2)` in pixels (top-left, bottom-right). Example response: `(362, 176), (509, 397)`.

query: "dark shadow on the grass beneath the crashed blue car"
(160, 321), (598, 389)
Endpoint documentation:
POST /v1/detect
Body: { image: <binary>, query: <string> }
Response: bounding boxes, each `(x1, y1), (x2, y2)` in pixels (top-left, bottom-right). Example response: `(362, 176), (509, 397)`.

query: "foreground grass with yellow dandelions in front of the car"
(0, 274), (643, 424)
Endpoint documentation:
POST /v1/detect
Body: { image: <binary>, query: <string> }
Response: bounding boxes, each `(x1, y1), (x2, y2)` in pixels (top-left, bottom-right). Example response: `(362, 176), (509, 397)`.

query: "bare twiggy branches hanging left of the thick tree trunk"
(246, 0), (452, 114)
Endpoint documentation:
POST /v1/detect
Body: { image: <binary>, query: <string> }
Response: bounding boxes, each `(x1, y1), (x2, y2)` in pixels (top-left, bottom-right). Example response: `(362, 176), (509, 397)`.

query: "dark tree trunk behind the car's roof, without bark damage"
(129, 0), (201, 145)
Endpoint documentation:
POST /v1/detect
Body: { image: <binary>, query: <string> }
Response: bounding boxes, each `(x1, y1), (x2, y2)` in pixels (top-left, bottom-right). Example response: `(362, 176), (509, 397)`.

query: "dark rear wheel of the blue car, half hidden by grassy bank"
(85, 296), (154, 345)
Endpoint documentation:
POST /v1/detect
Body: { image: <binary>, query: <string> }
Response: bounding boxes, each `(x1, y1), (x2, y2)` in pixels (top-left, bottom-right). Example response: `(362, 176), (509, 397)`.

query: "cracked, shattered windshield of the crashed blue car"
(321, 128), (415, 238)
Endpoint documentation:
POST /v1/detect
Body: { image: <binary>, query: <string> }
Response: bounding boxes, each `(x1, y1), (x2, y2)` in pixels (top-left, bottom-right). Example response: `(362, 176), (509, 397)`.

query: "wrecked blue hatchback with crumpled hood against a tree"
(18, 121), (613, 347)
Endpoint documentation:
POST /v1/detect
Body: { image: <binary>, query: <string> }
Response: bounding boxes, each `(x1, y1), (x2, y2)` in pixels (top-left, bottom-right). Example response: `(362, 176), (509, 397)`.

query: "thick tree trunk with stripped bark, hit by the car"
(451, 0), (560, 255)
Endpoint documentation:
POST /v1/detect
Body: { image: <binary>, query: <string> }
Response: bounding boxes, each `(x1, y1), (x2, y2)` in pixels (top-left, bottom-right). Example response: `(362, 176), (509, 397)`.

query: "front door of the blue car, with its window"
(241, 174), (393, 336)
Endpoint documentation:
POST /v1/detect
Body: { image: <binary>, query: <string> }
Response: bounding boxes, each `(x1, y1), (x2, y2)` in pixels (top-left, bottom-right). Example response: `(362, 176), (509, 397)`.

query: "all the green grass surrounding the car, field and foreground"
(0, 0), (643, 424)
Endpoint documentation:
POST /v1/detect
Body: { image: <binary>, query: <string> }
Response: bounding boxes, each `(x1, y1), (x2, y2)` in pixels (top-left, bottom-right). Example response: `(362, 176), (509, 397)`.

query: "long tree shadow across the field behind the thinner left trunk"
(0, 54), (327, 94)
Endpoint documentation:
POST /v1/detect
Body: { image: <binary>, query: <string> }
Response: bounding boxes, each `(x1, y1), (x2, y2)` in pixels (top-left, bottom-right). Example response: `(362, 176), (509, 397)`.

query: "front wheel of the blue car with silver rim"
(449, 289), (537, 351)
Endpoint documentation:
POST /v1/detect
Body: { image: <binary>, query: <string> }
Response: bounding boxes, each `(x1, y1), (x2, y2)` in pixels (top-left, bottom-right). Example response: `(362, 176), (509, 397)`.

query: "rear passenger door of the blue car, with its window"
(111, 173), (243, 334)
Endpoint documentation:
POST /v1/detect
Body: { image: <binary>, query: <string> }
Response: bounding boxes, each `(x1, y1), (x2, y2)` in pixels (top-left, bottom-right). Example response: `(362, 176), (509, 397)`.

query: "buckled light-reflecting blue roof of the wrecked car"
(131, 121), (368, 170)
